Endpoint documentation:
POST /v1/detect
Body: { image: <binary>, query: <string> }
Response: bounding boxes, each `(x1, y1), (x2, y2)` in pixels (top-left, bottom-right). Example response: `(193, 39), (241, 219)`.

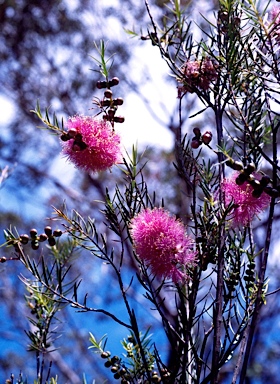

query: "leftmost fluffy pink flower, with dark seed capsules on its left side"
(62, 115), (122, 172)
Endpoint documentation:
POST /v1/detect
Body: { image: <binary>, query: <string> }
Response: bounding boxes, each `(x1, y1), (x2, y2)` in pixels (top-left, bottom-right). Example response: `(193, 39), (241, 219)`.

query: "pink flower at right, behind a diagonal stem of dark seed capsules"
(222, 172), (271, 226)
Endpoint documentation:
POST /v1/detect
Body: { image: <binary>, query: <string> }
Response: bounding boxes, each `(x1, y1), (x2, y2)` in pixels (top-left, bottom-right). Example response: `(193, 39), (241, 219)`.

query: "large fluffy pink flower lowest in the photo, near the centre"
(131, 208), (196, 282)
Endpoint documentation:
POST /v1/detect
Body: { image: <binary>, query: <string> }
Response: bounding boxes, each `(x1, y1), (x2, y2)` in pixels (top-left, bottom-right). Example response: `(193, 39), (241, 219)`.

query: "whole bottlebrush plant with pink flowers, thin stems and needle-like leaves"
(1, 0), (280, 384)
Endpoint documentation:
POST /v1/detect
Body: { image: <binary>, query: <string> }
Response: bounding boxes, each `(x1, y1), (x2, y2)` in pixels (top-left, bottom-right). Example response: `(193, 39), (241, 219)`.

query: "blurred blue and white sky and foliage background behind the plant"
(0, 0), (280, 384)
